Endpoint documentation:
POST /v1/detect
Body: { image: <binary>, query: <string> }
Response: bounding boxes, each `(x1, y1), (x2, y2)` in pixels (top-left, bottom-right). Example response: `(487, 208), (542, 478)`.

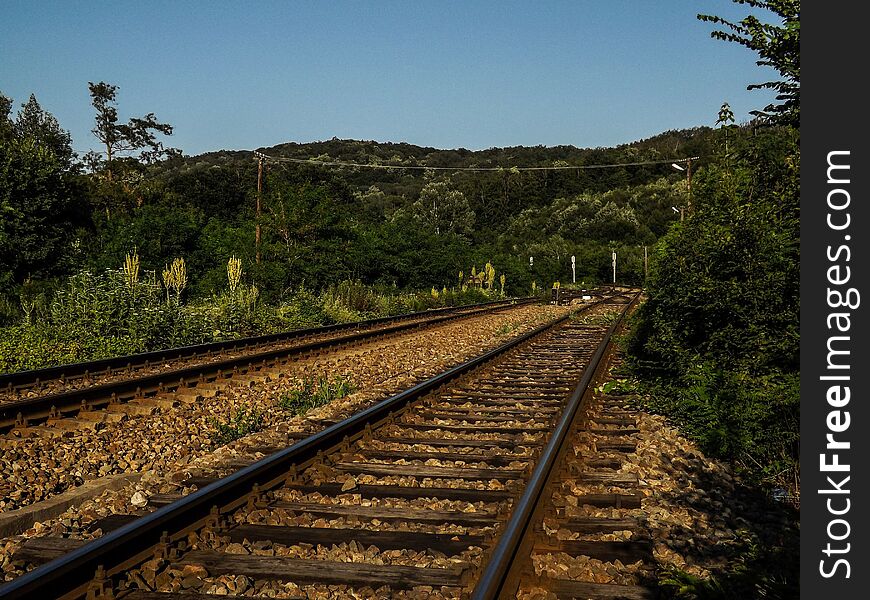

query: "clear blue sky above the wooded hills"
(0, 0), (775, 154)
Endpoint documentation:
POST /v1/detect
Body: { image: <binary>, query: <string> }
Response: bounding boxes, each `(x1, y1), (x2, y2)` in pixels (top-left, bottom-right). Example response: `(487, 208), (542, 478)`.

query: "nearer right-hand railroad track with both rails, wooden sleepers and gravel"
(0, 288), (636, 600)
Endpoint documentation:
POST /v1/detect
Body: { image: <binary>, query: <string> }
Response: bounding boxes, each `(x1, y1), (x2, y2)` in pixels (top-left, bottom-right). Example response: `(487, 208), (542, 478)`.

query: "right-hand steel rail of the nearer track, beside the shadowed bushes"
(471, 294), (640, 600)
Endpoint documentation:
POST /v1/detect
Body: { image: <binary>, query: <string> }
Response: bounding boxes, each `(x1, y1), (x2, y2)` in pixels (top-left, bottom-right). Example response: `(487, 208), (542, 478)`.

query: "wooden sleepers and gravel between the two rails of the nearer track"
(0, 304), (631, 598)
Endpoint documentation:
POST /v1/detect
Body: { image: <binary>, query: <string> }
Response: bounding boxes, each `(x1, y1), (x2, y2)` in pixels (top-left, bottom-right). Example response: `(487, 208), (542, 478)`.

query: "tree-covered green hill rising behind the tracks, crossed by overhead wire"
(124, 128), (722, 293)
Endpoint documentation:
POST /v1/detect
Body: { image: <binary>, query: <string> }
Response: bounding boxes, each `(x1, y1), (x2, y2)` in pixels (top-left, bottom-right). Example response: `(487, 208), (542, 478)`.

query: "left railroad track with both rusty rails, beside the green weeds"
(0, 299), (560, 434)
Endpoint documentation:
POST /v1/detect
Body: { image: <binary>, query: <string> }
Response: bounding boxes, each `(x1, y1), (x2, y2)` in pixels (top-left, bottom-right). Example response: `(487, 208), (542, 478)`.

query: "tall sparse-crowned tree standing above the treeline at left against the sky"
(88, 81), (178, 181)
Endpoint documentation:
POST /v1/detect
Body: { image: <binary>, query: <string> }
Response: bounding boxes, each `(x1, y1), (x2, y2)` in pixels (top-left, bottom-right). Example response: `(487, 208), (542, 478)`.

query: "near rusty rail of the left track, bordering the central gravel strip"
(0, 300), (536, 431)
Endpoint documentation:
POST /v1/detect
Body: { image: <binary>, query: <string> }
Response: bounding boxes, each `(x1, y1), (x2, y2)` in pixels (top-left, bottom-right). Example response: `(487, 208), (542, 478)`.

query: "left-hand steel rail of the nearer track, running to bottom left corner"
(0, 299), (616, 600)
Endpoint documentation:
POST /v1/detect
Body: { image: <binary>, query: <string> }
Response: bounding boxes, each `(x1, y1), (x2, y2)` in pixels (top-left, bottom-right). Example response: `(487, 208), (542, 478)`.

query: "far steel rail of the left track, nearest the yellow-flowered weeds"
(0, 298), (537, 389)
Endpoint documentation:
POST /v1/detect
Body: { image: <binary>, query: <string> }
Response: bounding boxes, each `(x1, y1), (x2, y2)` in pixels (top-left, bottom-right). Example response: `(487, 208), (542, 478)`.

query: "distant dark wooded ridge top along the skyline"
(162, 127), (720, 227)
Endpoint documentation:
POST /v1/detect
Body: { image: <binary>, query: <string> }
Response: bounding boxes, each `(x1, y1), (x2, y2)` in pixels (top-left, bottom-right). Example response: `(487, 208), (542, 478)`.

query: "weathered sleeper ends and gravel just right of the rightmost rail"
(510, 384), (657, 600)
